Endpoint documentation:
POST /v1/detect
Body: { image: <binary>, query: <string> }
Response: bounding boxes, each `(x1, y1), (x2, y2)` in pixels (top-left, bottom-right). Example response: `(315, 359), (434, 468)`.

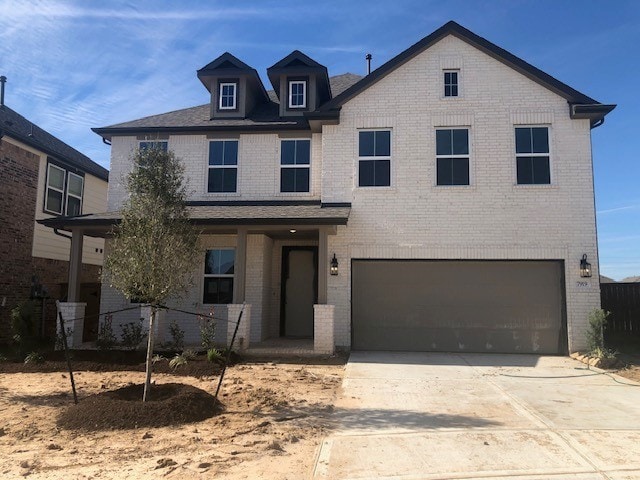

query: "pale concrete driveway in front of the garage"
(314, 352), (640, 480)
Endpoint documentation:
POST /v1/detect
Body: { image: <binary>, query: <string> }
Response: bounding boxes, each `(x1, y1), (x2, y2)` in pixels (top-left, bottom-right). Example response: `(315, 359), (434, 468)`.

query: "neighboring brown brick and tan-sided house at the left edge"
(0, 79), (108, 343)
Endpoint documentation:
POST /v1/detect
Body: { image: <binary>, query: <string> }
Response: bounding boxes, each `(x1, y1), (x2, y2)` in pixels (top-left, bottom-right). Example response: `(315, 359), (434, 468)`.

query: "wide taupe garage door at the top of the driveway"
(352, 260), (567, 354)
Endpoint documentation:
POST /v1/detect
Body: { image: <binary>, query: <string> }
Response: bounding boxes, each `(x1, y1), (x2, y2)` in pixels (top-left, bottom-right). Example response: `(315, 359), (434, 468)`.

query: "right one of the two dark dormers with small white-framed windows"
(267, 50), (331, 117)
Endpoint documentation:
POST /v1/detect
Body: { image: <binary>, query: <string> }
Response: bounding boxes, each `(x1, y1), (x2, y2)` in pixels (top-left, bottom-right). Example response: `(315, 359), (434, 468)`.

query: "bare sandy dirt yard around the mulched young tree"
(0, 359), (344, 480)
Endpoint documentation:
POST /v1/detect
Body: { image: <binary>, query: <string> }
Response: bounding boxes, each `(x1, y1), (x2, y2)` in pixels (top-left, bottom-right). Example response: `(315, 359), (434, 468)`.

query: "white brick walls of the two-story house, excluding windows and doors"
(101, 30), (600, 351)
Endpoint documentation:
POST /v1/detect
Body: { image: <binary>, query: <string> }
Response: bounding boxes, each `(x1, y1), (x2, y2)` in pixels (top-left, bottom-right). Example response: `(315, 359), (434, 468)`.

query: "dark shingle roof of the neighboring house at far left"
(0, 105), (109, 181)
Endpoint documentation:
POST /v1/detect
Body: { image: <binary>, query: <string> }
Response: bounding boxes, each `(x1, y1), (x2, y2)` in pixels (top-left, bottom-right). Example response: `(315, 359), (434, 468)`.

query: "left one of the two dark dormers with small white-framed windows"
(198, 52), (269, 120)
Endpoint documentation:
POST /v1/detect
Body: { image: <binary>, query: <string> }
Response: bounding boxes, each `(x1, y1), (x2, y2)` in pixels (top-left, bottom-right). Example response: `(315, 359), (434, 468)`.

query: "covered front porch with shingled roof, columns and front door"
(40, 201), (350, 355)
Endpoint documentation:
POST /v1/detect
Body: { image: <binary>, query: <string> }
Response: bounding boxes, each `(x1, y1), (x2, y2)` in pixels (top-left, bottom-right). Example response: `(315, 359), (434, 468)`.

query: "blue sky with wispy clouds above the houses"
(0, 0), (640, 280)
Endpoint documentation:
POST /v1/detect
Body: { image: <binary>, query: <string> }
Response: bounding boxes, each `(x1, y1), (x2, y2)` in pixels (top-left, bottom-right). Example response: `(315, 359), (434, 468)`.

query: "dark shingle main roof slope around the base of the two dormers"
(93, 73), (362, 137)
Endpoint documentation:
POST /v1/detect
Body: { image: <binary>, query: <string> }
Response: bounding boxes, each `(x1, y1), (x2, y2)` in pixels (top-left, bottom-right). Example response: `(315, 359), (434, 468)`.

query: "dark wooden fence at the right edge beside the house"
(600, 283), (640, 340)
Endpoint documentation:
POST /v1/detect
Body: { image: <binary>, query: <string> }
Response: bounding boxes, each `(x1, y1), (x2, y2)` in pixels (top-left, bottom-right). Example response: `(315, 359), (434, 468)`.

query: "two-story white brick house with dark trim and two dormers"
(45, 22), (615, 353)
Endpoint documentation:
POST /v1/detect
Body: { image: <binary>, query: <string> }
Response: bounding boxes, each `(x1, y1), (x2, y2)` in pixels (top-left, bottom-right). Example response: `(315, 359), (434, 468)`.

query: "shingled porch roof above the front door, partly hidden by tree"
(38, 202), (351, 237)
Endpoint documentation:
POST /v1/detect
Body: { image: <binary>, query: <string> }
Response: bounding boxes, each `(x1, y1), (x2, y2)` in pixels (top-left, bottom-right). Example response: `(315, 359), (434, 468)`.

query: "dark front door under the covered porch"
(280, 247), (318, 338)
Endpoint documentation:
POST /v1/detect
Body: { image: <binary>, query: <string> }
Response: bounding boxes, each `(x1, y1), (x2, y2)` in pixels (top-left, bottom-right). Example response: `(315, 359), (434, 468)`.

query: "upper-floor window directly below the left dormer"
(207, 140), (238, 193)
